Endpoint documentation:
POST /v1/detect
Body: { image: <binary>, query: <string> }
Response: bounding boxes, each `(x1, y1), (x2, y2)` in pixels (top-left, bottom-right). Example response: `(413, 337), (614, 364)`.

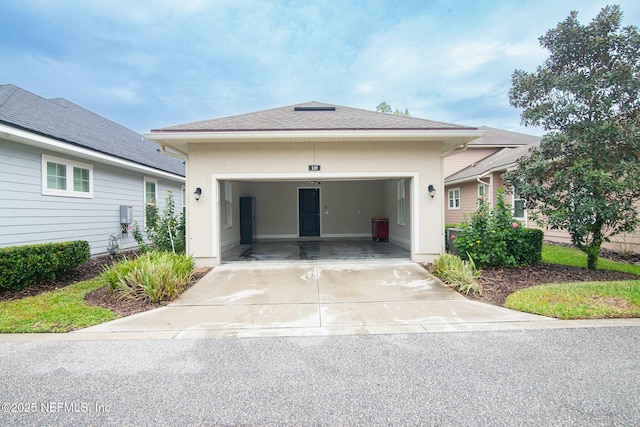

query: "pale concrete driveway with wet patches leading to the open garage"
(76, 260), (553, 338)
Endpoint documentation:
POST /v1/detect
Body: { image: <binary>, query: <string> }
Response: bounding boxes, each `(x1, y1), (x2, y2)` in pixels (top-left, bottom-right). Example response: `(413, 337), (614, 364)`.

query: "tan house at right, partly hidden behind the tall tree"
(445, 137), (640, 252)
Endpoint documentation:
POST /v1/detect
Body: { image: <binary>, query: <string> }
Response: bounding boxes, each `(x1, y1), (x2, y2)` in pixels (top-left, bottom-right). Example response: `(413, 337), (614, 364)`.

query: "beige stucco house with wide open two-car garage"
(146, 102), (483, 266)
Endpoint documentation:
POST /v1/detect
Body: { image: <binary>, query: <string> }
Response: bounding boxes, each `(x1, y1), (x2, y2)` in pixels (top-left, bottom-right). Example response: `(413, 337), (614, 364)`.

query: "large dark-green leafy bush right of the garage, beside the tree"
(454, 190), (543, 268)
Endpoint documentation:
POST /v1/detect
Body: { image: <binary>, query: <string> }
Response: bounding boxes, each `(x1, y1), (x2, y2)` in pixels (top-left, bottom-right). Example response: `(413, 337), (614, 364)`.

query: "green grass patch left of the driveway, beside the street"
(0, 280), (118, 333)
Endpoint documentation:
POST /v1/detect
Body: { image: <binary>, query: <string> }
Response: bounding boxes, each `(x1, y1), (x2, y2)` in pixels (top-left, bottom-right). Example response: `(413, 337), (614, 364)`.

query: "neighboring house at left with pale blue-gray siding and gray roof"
(0, 85), (185, 255)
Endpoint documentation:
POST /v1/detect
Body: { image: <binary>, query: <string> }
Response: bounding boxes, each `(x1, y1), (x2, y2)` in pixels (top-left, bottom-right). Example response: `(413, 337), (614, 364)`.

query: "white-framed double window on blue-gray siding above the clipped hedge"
(42, 154), (93, 198)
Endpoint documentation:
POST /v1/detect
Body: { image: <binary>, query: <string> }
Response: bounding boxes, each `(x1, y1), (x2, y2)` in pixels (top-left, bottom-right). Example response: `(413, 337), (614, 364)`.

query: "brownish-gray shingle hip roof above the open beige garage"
(152, 101), (476, 132)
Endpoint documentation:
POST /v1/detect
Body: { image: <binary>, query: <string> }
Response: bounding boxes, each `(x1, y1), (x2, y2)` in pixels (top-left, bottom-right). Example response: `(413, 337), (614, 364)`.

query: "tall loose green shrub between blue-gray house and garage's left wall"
(132, 190), (186, 253)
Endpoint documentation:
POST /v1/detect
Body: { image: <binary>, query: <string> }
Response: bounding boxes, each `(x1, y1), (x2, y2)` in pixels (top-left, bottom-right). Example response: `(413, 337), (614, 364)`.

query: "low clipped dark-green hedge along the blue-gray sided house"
(0, 240), (91, 289)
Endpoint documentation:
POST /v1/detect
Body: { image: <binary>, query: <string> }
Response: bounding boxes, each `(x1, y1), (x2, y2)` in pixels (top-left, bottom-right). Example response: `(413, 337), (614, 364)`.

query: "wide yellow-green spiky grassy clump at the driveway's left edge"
(98, 251), (194, 303)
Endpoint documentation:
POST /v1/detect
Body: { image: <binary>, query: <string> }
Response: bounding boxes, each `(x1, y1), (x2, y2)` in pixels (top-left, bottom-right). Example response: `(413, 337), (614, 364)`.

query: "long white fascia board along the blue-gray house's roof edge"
(0, 124), (185, 182)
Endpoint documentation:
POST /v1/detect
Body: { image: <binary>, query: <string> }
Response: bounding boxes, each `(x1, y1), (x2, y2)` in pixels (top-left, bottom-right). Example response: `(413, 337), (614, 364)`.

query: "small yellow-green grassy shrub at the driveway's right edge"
(429, 253), (482, 294)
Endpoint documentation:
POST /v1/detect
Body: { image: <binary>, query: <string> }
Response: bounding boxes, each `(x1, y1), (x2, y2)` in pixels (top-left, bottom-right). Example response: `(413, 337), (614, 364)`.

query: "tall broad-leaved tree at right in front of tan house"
(505, 6), (640, 269)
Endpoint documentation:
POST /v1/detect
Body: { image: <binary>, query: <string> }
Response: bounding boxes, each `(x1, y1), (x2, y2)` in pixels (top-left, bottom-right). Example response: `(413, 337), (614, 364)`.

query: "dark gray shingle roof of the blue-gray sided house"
(0, 85), (185, 176)
